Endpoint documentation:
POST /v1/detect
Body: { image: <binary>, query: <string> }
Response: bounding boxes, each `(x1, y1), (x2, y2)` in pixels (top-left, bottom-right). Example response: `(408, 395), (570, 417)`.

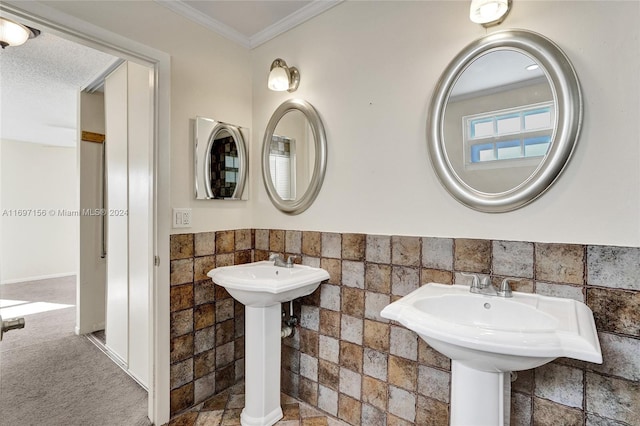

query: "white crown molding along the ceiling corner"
(153, 0), (344, 49)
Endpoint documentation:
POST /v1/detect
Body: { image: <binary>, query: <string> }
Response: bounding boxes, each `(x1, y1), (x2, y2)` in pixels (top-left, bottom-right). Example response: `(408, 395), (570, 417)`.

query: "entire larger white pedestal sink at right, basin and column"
(381, 283), (602, 426)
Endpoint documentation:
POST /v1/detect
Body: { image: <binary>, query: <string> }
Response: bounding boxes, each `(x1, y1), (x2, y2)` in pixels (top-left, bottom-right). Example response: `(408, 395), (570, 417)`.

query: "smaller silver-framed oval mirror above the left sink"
(262, 99), (327, 214)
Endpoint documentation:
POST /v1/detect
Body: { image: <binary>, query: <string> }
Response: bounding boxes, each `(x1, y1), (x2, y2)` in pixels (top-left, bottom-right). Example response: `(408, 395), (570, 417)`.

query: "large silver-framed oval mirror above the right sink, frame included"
(428, 30), (582, 212)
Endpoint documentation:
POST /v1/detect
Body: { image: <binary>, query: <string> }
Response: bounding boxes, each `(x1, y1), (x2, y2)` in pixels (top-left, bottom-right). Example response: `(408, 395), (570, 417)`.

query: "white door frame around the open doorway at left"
(0, 0), (171, 425)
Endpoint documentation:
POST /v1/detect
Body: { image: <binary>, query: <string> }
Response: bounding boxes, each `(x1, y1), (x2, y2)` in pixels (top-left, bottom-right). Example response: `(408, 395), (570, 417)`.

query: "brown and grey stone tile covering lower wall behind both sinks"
(171, 229), (640, 426)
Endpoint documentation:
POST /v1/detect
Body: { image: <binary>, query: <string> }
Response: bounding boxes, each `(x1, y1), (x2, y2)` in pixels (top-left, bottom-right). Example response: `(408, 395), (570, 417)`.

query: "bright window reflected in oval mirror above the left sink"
(269, 135), (296, 200)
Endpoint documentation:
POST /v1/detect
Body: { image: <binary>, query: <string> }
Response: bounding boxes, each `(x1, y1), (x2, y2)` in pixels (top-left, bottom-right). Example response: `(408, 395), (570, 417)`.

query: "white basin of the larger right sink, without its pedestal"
(381, 283), (602, 372)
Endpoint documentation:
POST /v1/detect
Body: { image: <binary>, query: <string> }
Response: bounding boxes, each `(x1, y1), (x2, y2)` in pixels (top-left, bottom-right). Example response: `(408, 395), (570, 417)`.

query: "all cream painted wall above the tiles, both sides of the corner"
(40, 0), (640, 246)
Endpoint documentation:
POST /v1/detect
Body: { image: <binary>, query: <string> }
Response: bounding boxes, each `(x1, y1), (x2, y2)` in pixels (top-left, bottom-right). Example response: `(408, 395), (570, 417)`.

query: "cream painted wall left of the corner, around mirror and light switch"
(43, 1), (254, 233)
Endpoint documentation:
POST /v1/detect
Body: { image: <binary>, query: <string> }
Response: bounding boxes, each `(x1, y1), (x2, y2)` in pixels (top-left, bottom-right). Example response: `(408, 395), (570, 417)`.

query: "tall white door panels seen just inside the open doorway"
(105, 62), (153, 386)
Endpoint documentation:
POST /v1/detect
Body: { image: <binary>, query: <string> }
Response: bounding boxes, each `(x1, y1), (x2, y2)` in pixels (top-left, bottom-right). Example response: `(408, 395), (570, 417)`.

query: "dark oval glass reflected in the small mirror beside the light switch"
(210, 132), (240, 198)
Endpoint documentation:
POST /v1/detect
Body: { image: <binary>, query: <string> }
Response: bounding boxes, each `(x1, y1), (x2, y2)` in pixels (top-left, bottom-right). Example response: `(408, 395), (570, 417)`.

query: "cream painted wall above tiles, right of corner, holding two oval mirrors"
(250, 0), (640, 246)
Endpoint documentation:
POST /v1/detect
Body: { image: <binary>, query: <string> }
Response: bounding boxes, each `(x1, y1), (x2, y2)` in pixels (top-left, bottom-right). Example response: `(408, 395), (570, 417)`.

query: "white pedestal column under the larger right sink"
(451, 360), (511, 426)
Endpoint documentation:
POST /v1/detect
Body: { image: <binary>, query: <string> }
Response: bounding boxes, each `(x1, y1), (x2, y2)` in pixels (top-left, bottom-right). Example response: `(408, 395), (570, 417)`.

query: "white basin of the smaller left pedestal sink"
(207, 260), (329, 307)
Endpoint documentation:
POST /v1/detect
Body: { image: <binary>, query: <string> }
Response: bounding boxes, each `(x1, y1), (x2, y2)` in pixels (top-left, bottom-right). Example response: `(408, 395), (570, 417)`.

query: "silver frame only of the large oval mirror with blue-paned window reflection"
(427, 30), (582, 213)
